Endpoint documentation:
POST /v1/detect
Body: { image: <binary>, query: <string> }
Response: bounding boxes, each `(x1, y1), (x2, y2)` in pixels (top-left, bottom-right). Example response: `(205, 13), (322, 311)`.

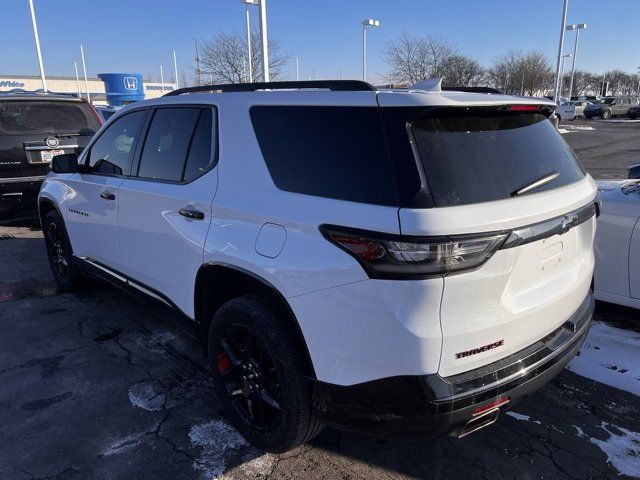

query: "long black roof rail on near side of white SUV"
(164, 80), (376, 97)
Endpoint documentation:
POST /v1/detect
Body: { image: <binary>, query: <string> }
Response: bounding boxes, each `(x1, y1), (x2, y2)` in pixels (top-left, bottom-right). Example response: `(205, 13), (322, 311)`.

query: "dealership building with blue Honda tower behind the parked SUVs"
(0, 73), (176, 106)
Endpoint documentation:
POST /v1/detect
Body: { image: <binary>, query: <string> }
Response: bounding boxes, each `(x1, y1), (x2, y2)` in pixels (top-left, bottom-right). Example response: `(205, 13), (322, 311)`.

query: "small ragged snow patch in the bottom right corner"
(588, 422), (640, 478)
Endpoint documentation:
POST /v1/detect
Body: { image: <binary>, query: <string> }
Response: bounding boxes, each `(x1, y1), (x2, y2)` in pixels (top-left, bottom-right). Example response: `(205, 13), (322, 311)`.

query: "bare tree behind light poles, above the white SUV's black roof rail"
(200, 32), (287, 83)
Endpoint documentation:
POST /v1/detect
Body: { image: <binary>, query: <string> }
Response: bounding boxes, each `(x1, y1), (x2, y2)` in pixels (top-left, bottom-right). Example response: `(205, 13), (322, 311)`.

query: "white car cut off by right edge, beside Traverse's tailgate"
(594, 164), (640, 308)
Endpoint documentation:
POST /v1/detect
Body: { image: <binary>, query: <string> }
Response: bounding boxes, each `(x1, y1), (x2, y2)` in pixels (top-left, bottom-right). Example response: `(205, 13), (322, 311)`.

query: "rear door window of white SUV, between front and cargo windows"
(138, 107), (214, 182)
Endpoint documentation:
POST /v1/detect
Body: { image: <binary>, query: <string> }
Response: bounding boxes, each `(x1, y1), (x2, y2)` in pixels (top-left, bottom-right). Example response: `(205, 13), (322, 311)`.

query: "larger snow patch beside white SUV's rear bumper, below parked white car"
(567, 322), (640, 395)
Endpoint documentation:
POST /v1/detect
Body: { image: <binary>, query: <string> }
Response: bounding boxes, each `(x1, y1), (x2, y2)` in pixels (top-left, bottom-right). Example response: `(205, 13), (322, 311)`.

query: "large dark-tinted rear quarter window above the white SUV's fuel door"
(250, 106), (397, 205)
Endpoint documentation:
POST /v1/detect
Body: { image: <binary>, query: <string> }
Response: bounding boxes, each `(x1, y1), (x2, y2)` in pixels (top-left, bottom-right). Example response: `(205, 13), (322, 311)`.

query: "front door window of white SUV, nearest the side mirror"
(87, 110), (147, 175)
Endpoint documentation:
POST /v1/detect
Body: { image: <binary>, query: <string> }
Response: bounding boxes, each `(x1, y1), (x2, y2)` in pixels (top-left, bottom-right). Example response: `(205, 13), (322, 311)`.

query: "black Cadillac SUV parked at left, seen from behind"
(0, 91), (102, 216)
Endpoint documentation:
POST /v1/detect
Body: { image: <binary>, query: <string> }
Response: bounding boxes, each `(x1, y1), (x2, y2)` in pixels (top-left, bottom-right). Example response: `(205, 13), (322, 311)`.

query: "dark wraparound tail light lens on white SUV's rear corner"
(320, 225), (508, 279)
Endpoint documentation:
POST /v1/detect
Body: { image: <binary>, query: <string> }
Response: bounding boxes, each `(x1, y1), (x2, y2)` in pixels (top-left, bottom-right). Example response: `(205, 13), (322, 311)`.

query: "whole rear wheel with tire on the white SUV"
(208, 295), (323, 453)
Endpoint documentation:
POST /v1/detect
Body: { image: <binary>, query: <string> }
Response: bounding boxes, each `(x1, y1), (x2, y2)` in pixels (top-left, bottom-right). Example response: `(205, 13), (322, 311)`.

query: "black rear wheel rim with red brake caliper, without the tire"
(217, 324), (282, 432)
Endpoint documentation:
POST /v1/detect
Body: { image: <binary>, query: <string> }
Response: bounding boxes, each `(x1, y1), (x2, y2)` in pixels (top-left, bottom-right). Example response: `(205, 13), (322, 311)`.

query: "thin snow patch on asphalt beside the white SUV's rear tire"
(189, 420), (274, 480)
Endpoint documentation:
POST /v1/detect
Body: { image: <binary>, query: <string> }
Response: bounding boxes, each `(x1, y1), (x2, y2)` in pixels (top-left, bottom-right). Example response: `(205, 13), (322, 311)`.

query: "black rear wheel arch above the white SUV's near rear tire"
(194, 263), (316, 379)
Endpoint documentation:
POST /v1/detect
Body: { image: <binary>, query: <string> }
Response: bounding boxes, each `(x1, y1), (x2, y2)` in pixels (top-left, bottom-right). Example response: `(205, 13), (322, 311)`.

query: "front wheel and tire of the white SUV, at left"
(42, 210), (82, 292)
